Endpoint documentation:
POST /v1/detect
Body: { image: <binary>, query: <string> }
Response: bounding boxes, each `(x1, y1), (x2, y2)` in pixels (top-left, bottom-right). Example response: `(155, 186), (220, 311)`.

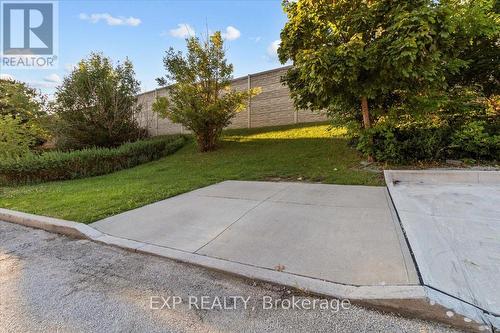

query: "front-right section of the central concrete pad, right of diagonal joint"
(197, 201), (417, 285)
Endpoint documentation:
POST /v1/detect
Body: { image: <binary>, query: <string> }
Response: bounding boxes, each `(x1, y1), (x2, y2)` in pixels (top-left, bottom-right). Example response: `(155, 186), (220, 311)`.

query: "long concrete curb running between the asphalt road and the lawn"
(0, 208), (490, 332)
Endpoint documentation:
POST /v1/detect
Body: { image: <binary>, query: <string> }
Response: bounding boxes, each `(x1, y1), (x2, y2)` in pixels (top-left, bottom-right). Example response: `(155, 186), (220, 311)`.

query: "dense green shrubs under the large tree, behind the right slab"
(355, 88), (500, 163)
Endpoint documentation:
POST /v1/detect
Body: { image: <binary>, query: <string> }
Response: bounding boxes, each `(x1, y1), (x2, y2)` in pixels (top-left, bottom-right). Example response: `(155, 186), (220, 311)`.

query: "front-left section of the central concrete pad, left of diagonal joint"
(92, 194), (259, 252)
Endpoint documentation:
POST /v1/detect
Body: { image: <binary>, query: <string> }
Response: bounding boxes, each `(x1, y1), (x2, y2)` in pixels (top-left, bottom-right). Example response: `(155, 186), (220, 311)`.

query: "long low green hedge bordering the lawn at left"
(0, 136), (187, 185)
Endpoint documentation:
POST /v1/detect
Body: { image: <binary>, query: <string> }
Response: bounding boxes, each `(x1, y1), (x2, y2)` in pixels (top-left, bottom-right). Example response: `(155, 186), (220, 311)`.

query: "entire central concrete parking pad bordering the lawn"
(91, 181), (418, 286)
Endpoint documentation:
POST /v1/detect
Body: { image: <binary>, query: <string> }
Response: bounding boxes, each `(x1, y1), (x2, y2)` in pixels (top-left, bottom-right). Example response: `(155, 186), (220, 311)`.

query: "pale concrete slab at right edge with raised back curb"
(386, 171), (500, 317)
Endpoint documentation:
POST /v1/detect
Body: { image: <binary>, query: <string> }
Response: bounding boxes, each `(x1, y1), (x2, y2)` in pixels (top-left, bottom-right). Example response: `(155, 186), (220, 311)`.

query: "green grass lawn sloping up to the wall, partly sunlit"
(0, 124), (383, 223)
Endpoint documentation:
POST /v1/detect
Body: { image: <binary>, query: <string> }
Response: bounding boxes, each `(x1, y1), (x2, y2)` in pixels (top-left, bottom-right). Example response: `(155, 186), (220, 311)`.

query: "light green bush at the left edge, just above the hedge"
(0, 115), (35, 160)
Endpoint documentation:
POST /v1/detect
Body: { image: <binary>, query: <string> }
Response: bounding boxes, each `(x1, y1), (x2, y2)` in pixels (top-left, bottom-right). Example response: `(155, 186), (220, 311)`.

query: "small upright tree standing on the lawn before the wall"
(153, 32), (259, 152)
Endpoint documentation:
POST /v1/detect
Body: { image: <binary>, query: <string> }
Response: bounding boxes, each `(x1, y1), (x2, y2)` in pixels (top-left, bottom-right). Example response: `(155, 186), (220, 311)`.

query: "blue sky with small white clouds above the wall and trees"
(1, 0), (286, 94)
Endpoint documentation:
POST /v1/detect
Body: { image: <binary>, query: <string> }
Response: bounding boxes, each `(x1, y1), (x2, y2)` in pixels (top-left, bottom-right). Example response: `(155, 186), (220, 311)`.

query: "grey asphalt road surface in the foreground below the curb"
(0, 222), (457, 333)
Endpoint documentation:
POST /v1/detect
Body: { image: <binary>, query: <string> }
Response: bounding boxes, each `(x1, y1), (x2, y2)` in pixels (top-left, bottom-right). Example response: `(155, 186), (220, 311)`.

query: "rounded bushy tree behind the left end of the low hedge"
(54, 53), (142, 149)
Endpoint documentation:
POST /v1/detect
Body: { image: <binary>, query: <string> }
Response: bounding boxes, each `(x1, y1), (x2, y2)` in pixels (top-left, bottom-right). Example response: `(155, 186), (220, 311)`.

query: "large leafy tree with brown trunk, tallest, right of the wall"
(278, 0), (467, 129)
